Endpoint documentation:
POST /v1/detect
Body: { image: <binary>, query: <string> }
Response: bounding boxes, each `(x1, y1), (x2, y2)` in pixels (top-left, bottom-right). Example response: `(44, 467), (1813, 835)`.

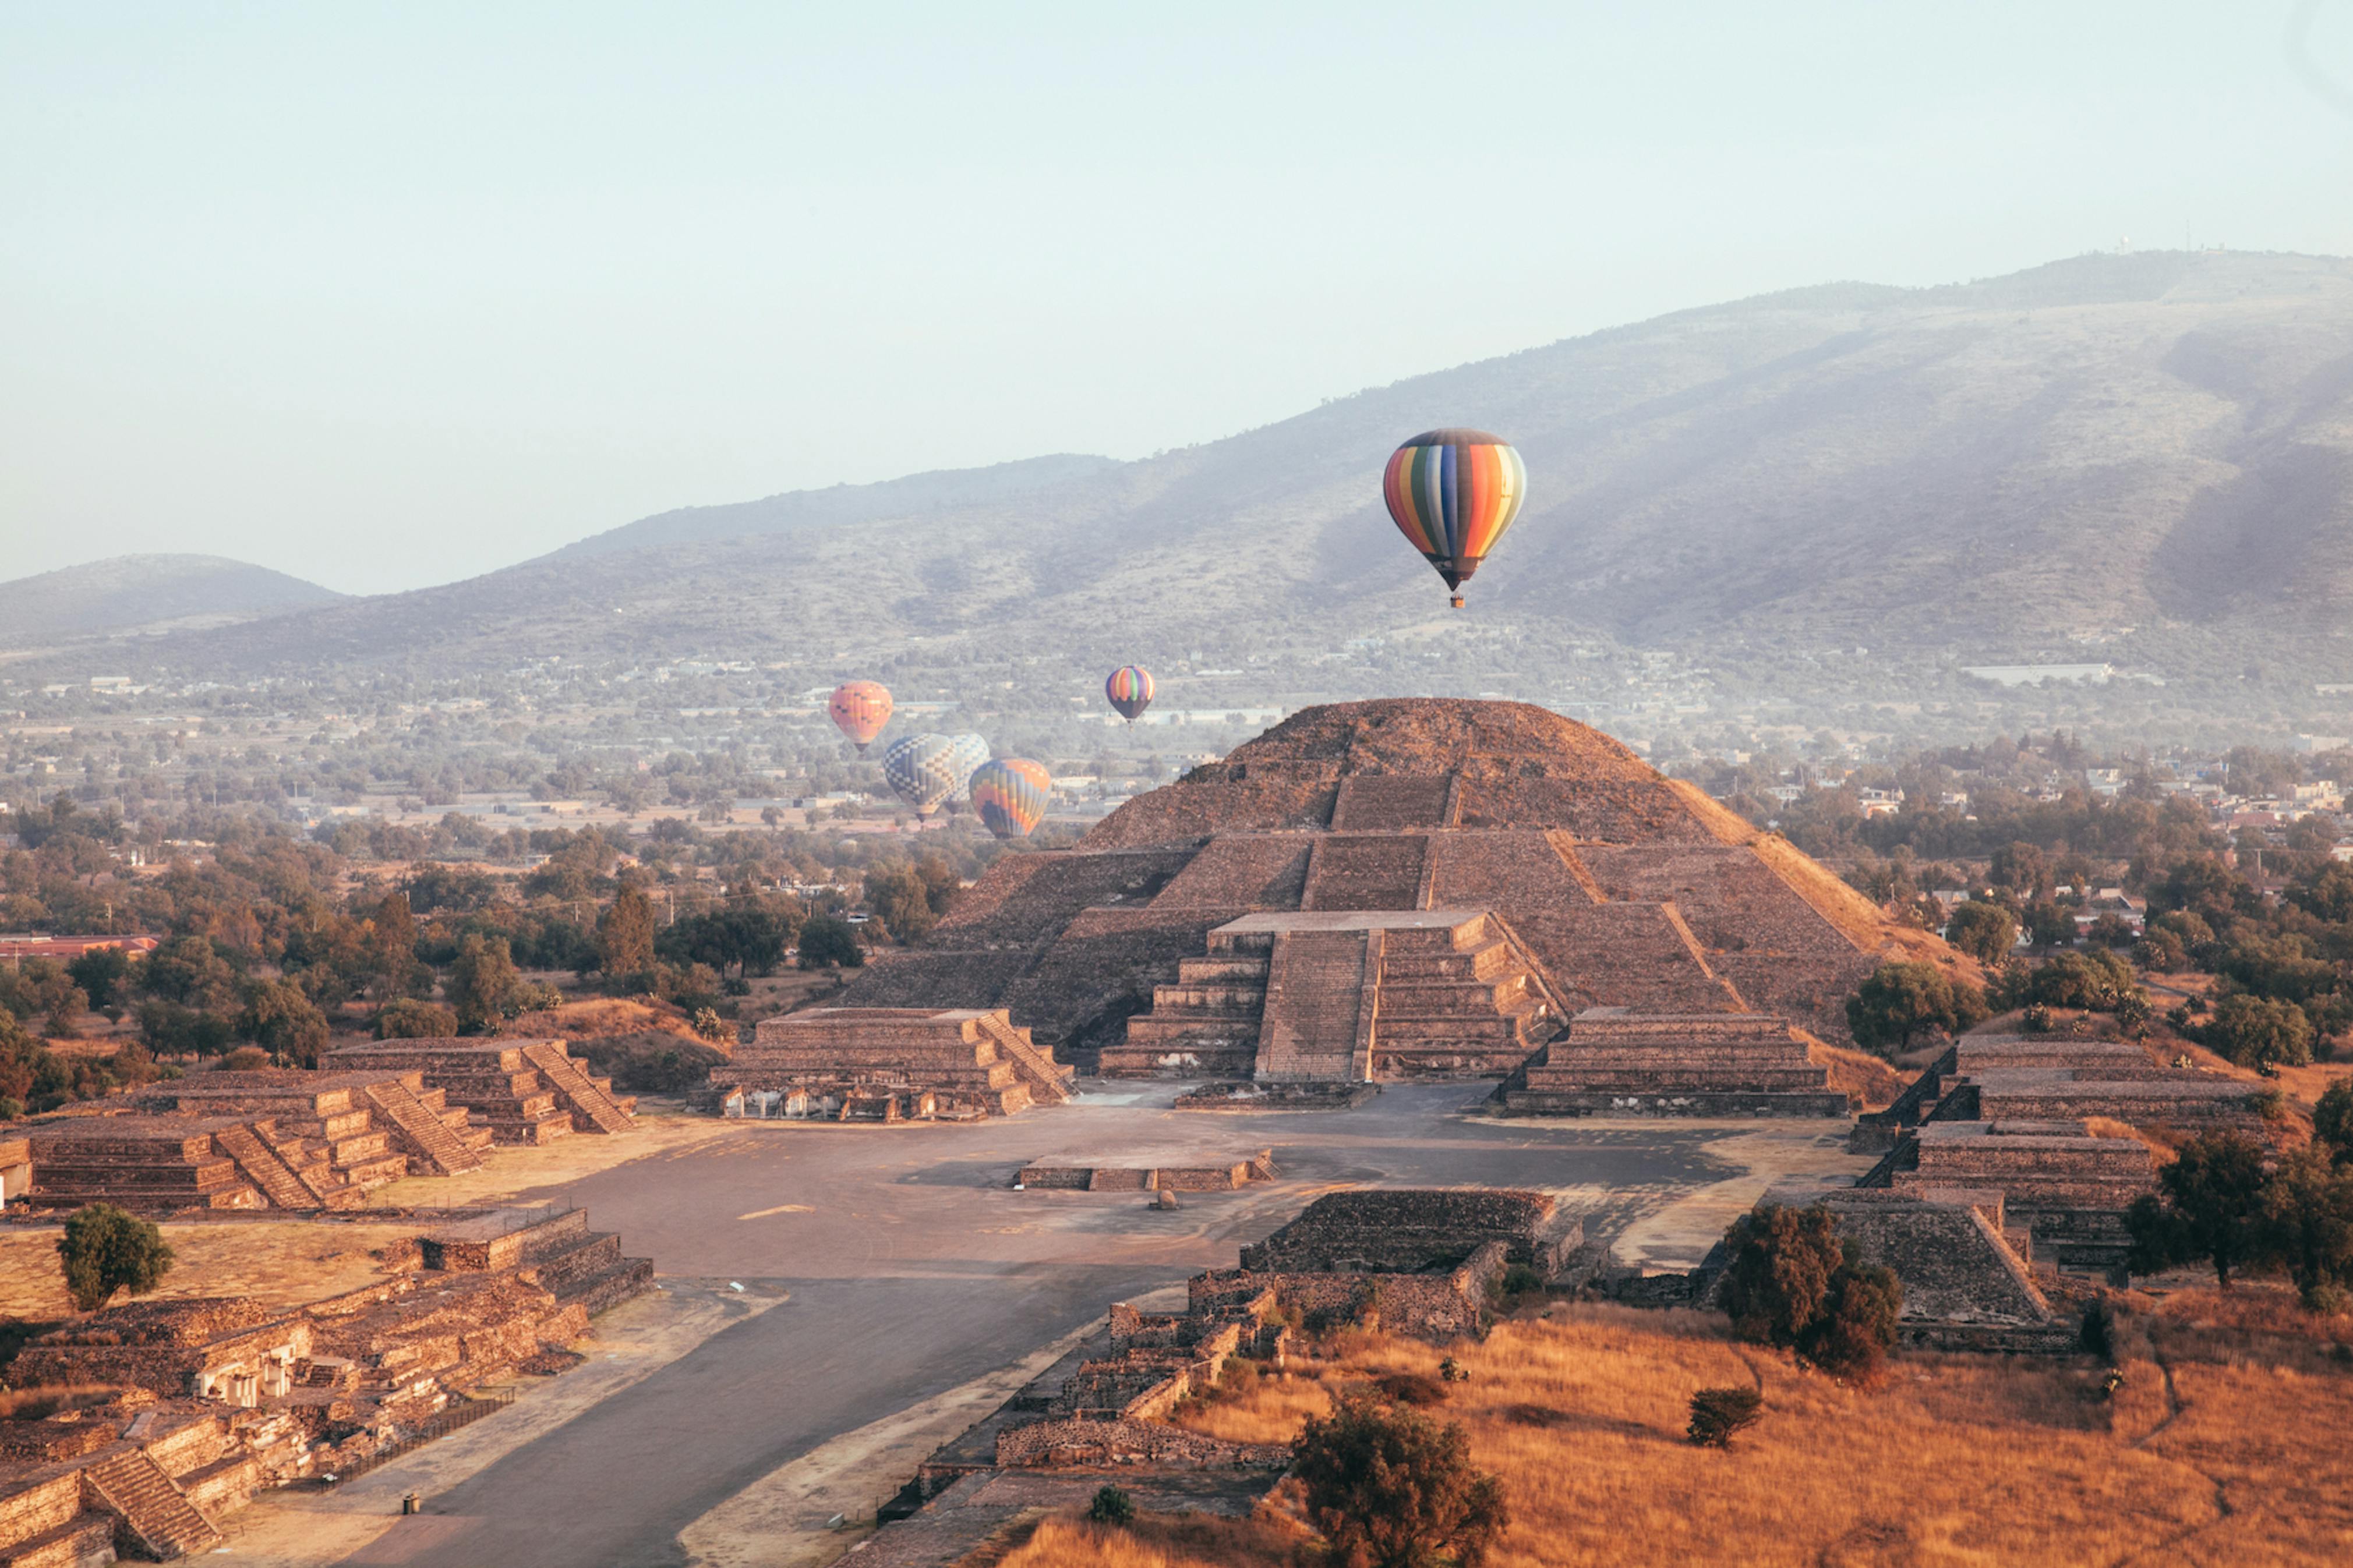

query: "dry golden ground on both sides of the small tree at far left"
(0, 1220), (419, 1321)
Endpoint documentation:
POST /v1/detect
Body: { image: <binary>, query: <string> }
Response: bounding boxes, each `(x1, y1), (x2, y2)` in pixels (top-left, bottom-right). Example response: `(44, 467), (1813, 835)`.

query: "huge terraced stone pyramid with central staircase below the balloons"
(840, 700), (1974, 1088)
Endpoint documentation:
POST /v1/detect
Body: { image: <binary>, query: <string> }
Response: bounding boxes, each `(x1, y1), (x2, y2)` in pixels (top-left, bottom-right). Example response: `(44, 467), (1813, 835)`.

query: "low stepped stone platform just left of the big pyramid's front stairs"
(711, 1006), (1070, 1121)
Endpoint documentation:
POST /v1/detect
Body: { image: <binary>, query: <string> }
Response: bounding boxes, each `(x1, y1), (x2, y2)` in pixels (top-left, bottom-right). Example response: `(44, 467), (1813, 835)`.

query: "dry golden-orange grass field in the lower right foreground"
(1040, 1291), (2353, 1568)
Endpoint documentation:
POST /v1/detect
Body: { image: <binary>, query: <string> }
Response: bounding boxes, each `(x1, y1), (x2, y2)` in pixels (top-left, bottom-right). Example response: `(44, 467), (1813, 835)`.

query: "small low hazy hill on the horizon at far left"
(0, 555), (346, 649)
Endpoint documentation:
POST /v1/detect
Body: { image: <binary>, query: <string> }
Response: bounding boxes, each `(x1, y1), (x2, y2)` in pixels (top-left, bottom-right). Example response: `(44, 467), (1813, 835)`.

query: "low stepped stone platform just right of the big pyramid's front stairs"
(1496, 1008), (1849, 1117)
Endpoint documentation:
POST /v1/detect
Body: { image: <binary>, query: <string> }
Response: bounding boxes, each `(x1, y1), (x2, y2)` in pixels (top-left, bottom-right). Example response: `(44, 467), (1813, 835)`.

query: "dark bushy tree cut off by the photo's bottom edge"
(1292, 1394), (1511, 1568)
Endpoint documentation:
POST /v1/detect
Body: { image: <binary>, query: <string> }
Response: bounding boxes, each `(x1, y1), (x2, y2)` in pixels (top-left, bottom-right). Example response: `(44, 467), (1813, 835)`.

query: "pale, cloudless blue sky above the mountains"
(0, 0), (2353, 592)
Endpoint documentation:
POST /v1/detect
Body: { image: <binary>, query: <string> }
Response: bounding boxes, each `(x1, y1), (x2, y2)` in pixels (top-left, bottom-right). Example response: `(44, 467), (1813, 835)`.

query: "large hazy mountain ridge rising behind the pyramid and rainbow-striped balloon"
(41, 252), (2353, 691)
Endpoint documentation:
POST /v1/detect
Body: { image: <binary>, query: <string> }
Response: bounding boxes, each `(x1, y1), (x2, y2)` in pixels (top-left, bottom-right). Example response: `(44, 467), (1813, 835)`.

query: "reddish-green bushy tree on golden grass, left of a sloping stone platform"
(1725, 1204), (1903, 1378)
